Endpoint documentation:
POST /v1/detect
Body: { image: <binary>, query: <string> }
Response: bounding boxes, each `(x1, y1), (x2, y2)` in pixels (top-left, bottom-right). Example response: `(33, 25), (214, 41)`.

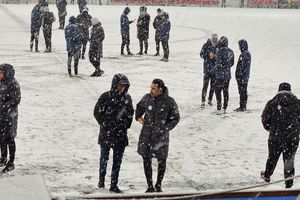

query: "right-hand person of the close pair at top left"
(43, 7), (55, 53)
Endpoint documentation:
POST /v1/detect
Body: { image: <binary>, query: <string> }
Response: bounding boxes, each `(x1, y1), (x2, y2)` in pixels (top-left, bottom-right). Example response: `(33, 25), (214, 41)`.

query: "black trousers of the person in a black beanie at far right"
(265, 138), (299, 184)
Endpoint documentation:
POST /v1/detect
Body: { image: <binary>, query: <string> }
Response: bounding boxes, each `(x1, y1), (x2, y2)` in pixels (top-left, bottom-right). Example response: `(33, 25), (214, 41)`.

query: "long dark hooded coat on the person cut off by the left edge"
(0, 64), (21, 139)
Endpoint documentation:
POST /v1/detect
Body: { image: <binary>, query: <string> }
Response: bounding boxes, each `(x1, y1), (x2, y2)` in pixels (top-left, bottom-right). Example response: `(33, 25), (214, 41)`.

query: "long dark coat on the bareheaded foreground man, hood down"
(135, 87), (180, 159)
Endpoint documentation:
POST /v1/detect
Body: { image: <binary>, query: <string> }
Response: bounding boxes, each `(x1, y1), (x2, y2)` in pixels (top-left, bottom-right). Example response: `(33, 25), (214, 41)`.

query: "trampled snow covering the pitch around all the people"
(0, 5), (300, 196)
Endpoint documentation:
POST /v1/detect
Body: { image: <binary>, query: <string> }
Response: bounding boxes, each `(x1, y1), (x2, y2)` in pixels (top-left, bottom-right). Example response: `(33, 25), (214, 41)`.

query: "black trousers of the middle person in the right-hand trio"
(215, 80), (230, 110)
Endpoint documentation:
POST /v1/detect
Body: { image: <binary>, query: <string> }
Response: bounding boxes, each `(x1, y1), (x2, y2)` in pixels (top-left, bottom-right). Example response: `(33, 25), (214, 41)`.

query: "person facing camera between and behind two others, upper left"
(77, 7), (92, 59)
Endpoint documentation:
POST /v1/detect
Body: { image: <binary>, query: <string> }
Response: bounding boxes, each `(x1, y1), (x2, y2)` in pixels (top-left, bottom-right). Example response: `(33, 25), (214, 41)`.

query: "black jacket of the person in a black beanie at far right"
(261, 91), (300, 142)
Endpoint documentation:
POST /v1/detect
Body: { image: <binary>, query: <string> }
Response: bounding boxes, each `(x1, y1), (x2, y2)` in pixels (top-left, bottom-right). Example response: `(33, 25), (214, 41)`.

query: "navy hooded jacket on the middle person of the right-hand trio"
(215, 36), (234, 82)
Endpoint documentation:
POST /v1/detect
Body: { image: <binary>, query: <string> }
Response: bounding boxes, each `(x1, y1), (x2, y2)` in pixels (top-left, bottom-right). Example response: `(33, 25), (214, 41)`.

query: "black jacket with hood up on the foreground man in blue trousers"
(94, 74), (134, 147)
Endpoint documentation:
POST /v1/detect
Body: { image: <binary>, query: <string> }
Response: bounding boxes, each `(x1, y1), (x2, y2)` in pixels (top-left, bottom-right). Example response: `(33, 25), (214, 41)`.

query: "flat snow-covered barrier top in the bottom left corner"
(0, 175), (51, 200)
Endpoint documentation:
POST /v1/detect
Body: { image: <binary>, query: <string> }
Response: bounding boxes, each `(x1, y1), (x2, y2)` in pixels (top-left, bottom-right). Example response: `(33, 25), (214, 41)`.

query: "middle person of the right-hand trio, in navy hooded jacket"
(214, 36), (234, 114)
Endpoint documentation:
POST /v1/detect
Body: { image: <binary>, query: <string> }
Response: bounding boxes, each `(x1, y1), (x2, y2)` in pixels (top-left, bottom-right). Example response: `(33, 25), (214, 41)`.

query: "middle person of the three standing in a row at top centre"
(136, 6), (150, 55)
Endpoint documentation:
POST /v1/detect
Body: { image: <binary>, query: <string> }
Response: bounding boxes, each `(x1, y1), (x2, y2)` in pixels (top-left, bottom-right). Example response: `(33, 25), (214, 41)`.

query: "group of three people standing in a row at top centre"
(120, 6), (171, 62)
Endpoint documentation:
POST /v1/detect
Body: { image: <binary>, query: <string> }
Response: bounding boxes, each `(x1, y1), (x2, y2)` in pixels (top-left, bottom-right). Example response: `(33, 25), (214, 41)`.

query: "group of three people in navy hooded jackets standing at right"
(200, 34), (251, 114)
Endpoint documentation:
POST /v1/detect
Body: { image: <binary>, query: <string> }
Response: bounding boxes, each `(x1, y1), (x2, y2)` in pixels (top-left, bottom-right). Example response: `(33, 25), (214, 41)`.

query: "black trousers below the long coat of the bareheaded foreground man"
(143, 157), (167, 187)
